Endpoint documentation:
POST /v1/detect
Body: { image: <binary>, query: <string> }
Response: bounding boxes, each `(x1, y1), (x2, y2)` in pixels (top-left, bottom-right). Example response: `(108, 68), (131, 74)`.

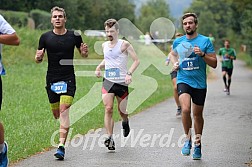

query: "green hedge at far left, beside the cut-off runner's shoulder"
(0, 10), (28, 27)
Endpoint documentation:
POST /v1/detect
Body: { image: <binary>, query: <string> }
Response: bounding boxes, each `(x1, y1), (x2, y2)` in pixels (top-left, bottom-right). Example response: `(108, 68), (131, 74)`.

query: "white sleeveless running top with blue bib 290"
(103, 39), (128, 83)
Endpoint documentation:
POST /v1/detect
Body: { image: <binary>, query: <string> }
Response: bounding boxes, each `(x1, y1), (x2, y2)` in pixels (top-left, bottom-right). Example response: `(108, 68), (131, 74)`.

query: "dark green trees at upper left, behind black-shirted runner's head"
(0, 0), (135, 30)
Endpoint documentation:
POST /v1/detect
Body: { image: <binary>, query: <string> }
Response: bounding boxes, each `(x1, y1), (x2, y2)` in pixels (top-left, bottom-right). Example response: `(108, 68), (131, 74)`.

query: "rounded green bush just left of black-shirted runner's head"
(30, 9), (51, 30)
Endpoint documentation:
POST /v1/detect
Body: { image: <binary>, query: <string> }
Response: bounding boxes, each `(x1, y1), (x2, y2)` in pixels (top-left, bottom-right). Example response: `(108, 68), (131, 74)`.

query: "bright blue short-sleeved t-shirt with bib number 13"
(173, 34), (215, 89)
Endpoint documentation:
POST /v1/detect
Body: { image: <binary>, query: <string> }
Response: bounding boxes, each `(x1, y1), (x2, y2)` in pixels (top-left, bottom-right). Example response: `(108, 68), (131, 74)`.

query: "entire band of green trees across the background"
(0, 0), (252, 55)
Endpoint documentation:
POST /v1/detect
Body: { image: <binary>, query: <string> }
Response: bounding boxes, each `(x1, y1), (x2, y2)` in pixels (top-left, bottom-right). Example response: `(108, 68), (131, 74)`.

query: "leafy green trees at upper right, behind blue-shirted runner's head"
(186, 0), (252, 53)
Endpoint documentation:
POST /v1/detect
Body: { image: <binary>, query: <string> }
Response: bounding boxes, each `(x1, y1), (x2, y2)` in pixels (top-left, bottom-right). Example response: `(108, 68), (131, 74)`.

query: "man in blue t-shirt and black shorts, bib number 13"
(169, 13), (217, 159)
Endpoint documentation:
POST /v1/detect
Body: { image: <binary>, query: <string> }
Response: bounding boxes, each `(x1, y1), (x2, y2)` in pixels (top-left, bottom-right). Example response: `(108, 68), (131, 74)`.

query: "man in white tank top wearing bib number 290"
(95, 19), (139, 150)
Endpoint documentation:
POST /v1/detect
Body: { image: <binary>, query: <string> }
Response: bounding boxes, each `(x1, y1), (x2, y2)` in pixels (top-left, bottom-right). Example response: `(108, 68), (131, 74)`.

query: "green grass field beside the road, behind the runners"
(0, 29), (172, 162)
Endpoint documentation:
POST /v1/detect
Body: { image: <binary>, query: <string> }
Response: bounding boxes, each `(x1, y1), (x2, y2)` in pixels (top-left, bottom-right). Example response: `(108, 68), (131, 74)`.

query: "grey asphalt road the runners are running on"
(11, 60), (252, 167)
